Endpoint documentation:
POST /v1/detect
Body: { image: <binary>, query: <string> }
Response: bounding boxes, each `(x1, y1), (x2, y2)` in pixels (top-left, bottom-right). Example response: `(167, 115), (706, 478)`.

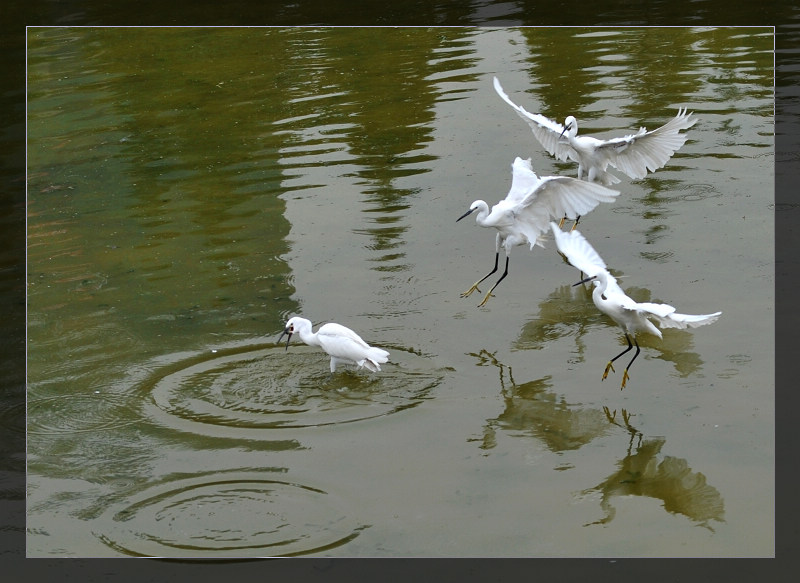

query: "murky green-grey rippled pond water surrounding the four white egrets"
(28, 28), (775, 557)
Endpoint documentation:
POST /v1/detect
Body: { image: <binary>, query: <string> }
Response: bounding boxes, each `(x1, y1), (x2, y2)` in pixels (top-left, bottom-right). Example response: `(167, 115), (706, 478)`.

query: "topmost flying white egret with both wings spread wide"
(494, 77), (697, 186)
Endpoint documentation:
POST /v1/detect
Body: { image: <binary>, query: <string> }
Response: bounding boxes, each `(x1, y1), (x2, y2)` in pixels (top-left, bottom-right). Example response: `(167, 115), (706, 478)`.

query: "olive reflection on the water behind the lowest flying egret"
(514, 280), (703, 378)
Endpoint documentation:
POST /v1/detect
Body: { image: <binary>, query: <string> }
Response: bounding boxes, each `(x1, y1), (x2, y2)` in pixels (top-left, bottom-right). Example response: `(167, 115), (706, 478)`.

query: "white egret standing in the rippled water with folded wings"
(278, 316), (389, 374)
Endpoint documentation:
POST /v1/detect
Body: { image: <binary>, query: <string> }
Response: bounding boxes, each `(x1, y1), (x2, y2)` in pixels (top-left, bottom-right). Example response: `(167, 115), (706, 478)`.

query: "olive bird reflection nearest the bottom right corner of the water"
(581, 422), (725, 532)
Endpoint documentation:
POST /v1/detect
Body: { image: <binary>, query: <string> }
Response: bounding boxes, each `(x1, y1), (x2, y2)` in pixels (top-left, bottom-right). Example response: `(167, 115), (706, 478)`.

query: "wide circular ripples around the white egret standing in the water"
(139, 344), (443, 437)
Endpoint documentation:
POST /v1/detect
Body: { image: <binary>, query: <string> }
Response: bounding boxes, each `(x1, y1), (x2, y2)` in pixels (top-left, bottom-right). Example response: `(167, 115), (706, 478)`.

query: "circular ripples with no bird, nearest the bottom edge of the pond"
(94, 472), (364, 558)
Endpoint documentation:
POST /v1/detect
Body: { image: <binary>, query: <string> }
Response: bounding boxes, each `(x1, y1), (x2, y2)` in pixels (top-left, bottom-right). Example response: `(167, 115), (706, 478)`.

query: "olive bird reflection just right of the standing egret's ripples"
(471, 350), (608, 452)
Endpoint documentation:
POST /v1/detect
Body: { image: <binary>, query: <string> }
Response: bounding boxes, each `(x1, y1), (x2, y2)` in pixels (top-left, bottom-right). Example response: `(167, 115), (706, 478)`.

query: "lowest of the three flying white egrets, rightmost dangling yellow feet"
(550, 222), (722, 389)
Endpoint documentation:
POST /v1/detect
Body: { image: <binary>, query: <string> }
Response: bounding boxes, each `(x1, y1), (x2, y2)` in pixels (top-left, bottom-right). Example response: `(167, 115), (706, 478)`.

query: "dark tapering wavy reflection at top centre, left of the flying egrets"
(282, 28), (477, 272)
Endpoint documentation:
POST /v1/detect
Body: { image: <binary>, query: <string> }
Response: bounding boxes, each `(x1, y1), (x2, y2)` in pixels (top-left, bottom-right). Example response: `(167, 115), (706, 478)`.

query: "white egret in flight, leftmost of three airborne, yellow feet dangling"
(456, 157), (619, 307)
